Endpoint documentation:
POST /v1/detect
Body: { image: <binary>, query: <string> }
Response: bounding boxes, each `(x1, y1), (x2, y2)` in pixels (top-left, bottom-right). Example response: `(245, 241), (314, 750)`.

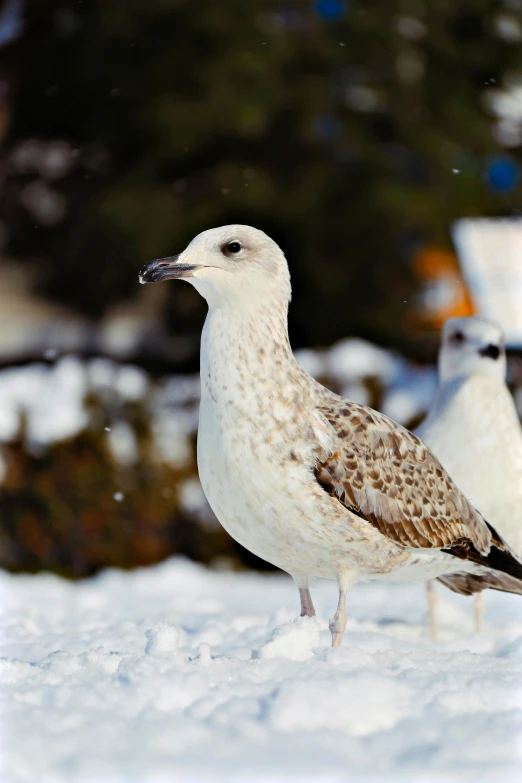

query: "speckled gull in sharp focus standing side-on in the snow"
(140, 225), (522, 646)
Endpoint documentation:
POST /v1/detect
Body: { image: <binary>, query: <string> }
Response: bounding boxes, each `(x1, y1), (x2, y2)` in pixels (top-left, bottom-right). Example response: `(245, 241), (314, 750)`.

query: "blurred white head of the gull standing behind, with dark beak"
(439, 316), (506, 382)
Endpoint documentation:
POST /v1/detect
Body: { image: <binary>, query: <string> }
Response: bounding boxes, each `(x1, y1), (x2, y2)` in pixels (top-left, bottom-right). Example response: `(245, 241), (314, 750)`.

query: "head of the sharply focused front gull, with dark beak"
(139, 225), (290, 307)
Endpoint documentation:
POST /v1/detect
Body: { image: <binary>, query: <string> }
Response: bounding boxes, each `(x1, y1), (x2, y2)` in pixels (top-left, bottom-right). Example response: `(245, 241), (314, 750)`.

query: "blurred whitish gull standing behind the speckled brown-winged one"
(416, 317), (522, 637)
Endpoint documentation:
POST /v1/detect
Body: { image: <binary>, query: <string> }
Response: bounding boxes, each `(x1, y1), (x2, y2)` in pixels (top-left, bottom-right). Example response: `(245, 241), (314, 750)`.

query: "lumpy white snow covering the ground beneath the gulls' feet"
(0, 559), (522, 783)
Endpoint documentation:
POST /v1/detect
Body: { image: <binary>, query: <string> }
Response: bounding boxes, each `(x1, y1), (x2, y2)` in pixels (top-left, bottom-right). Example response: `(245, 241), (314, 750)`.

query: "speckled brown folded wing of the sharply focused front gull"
(316, 398), (491, 557)
